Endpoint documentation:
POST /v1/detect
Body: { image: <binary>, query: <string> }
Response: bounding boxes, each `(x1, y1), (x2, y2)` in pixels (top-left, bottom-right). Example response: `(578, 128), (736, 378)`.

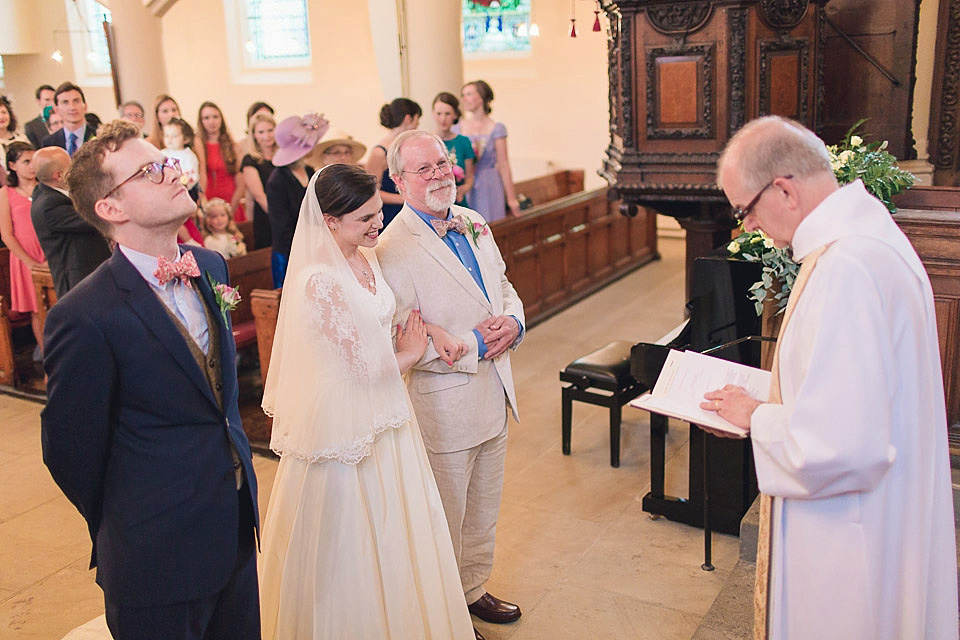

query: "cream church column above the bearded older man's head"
(368, 0), (463, 107)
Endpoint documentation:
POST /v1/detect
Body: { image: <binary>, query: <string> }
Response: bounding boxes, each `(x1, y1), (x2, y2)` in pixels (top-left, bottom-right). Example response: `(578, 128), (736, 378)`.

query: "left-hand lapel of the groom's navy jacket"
(110, 249), (223, 408)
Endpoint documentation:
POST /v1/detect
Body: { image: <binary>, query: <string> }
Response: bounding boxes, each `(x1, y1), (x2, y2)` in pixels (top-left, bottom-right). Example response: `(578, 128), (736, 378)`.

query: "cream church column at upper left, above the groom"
(104, 0), (167, 110)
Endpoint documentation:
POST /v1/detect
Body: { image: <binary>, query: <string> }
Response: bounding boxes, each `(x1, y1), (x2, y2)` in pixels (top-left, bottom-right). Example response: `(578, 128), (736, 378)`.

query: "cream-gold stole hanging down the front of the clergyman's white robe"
(753, 244), (830, 640)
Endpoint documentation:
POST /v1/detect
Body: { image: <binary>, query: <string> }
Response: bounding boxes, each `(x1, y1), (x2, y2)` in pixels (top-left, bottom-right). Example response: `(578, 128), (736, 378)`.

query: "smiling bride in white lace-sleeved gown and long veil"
(260, 165), (474, 640)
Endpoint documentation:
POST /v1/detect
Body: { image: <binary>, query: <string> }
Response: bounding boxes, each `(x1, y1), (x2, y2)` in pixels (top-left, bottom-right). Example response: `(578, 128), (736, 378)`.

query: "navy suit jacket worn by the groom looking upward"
(41, 247), (259, 607)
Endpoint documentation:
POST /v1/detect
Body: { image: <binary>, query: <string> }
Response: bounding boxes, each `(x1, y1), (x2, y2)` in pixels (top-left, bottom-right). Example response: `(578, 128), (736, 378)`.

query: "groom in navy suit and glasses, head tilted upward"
(41, 121), (260, 640)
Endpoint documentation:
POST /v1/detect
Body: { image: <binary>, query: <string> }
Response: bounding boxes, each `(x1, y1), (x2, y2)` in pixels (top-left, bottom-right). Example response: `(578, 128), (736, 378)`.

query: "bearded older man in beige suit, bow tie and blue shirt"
(377, 131), (523, 635)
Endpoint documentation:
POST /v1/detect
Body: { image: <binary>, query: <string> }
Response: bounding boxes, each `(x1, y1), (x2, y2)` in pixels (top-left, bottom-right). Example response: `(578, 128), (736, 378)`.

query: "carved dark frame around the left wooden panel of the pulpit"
(647, 46), (713, 140)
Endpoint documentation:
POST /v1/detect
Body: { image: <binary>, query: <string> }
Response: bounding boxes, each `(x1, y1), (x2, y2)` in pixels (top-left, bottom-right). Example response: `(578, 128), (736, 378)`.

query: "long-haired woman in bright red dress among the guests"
(194, 102), (246, 222)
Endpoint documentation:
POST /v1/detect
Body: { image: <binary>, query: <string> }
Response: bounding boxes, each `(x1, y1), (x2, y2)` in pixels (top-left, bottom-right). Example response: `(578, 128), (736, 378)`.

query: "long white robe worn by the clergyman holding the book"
(751, 181), (957, 640)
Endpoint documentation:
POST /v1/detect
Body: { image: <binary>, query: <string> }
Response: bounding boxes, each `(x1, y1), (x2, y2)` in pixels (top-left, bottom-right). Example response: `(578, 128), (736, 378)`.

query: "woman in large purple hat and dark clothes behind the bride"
(266, 113), (330, 288)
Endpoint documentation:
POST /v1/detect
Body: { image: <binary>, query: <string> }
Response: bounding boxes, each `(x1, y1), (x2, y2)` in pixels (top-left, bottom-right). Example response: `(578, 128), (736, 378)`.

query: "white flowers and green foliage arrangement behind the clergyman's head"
(727, 120), (915, 316)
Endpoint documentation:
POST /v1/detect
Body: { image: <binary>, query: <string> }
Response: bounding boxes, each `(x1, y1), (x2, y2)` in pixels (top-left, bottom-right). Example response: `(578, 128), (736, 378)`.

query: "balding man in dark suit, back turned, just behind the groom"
(30, 147), (110, 299)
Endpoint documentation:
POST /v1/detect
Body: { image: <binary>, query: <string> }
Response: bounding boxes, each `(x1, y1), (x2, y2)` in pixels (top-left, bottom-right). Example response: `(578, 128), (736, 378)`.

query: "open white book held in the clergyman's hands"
(630, 349), (770, 437)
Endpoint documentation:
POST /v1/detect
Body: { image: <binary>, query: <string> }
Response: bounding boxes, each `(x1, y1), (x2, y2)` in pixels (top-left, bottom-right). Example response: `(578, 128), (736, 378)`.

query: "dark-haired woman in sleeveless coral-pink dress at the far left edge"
(0, 142), (46, 346)
